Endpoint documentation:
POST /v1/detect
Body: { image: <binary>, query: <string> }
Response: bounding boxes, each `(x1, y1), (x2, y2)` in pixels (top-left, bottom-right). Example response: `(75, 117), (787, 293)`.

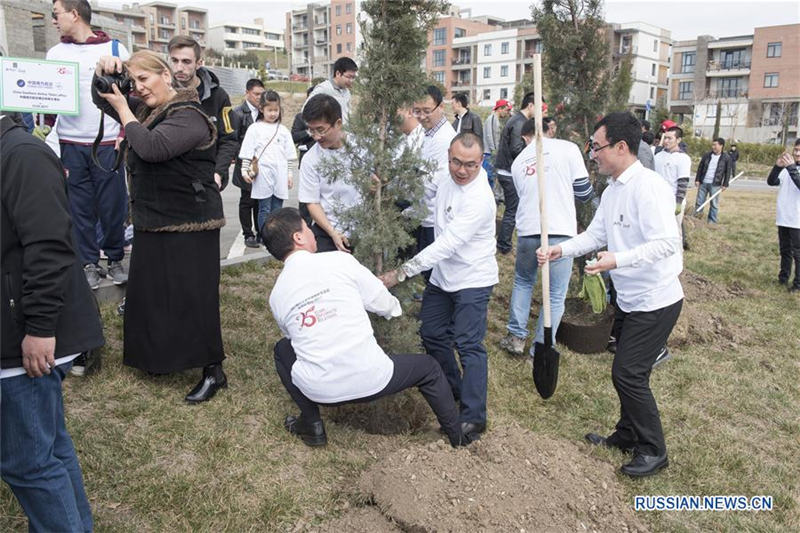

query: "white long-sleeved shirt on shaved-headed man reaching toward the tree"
(403, 168), (498, 292)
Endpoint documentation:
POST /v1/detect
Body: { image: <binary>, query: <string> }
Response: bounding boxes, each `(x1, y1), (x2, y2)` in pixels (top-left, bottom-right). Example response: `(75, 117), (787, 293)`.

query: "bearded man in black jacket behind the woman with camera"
(167, 35), (239, 190)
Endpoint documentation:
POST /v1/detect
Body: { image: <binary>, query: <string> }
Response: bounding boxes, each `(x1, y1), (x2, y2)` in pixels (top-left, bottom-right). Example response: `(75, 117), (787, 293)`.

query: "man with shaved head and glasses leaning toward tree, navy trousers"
(380, 133), (498, 440)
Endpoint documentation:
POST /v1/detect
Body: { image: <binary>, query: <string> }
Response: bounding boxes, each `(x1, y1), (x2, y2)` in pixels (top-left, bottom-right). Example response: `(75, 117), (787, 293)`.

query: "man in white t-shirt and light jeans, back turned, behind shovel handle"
(500, 119), (594, 355)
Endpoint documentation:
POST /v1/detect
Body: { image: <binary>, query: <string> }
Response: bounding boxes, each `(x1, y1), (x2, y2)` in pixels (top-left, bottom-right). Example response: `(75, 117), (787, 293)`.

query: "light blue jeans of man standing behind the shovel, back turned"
(506, 235), (572, 342)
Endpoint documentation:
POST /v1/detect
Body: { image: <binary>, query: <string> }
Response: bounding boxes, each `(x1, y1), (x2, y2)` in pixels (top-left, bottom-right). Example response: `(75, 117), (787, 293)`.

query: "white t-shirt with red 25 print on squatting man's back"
(269, 250), (402, 403)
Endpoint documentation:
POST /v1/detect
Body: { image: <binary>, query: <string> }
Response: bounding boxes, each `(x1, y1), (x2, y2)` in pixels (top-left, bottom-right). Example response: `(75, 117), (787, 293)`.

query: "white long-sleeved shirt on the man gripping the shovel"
(561, 161), (683, 313)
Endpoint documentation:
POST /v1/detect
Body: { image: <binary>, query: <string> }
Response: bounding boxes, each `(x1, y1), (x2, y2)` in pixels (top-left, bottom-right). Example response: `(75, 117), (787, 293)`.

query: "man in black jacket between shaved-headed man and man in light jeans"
(494, 93), (536, 254)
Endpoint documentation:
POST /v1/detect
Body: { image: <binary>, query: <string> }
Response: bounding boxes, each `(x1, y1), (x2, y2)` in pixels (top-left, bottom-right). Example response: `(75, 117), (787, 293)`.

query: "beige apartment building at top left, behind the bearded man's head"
(92, 2), (208, 52)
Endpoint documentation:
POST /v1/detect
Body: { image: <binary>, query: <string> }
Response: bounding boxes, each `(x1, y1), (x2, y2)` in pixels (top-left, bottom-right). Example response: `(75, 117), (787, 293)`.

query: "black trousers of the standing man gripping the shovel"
(609, 300), (683, 455)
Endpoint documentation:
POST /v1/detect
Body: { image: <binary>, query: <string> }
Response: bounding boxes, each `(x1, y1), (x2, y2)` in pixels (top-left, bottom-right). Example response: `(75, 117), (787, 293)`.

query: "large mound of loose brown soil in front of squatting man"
(360, 426), (646, 531)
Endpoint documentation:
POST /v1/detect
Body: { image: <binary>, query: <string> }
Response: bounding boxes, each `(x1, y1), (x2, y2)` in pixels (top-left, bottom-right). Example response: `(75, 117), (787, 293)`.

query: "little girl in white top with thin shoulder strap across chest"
(239, 90), (297, 234)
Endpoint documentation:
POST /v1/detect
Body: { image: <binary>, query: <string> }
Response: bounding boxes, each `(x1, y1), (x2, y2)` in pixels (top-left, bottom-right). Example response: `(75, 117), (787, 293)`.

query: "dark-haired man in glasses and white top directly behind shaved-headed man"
(411, 85), (456, 280)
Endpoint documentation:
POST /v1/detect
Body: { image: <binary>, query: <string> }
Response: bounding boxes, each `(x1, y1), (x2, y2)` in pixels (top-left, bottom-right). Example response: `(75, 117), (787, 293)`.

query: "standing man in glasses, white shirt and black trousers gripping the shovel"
(536, 112), (683, 477)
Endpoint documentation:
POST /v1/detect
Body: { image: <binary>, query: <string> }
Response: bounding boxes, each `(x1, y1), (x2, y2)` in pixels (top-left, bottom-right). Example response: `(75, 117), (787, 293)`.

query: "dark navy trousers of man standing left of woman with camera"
(61, 143), (128, 264)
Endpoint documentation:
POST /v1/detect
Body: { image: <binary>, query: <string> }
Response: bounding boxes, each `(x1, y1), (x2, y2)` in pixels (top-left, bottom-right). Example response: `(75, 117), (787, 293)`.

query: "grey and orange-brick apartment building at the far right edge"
(669, 24), (800, 142)
